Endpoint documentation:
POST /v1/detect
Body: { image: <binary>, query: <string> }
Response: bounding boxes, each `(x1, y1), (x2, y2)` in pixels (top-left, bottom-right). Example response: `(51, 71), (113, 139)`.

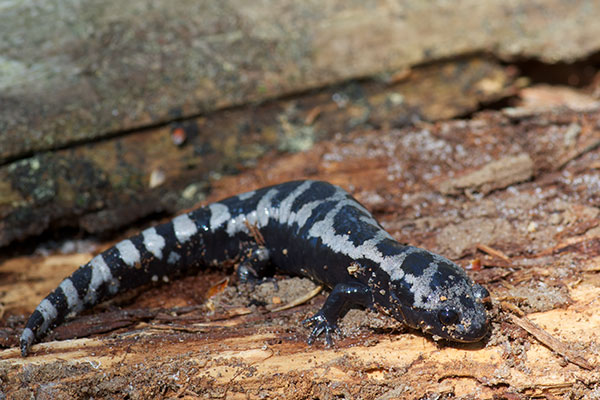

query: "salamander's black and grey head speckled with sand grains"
(388, 249), (489, 342)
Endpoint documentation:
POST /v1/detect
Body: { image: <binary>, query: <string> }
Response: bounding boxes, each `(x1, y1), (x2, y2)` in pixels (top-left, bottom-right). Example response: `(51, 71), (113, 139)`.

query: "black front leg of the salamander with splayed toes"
(303, 283), (373, 346)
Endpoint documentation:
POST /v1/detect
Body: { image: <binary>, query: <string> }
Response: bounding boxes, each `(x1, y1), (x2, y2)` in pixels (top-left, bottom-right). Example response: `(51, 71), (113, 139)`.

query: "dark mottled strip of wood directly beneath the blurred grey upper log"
(0, 57), (519, 248)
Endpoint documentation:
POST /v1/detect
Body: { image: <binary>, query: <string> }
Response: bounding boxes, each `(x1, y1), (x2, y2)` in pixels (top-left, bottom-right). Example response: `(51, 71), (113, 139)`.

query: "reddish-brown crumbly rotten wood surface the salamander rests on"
(0, 104), (600, 399)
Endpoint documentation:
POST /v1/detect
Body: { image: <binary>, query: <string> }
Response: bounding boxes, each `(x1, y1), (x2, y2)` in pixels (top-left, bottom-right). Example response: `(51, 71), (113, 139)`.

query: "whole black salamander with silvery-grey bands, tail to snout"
(21, 181), (489, 356)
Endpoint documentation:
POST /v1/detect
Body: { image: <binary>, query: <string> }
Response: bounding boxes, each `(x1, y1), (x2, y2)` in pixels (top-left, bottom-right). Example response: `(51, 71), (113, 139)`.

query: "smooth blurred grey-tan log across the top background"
(0, 0), (600, 164)
